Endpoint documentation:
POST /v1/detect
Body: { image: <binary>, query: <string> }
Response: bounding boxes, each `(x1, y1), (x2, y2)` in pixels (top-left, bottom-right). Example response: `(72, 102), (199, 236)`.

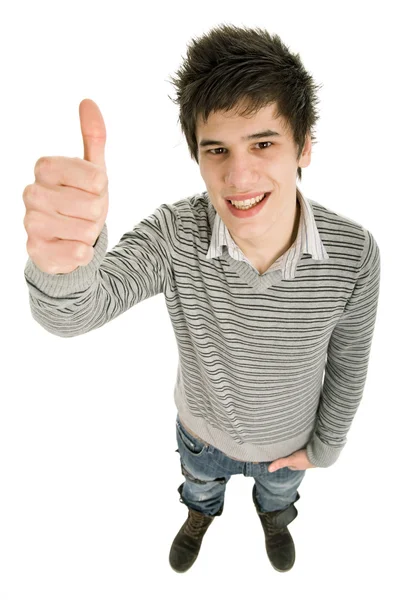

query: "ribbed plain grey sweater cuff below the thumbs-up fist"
(24, 223), (108, 299)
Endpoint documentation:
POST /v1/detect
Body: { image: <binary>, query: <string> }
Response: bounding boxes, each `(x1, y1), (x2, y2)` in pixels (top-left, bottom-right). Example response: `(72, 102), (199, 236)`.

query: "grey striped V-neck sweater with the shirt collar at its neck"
(24, 187), (380, 467)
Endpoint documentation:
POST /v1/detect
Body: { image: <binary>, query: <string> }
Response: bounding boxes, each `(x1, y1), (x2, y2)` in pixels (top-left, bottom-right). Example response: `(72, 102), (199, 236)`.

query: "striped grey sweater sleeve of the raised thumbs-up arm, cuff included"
(24, 204), (176, 337)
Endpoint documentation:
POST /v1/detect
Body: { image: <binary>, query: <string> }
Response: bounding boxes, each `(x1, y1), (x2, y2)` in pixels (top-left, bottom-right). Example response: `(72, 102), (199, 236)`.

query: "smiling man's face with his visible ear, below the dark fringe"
(196, 104), (311, 248)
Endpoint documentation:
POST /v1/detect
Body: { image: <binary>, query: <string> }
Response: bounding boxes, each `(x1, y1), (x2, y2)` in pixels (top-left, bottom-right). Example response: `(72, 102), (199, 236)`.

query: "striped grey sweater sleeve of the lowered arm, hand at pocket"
(306, 228), (380, 467)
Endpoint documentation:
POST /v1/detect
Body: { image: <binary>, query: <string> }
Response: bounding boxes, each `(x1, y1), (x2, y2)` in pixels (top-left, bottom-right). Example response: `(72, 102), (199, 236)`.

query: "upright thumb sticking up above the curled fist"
(79, 98), (106, 169)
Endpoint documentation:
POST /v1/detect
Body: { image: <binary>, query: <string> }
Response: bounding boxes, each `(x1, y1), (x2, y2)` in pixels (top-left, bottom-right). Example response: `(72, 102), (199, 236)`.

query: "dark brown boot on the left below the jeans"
(169, 484), (223, 573)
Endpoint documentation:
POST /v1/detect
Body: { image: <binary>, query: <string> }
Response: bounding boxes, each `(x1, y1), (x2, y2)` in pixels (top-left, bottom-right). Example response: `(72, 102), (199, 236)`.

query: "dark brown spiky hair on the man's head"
(169, 24), (322, 180)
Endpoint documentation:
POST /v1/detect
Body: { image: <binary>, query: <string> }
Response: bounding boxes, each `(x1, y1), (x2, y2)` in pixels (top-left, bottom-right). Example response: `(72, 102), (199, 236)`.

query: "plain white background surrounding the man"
(0, 0), (419, 600)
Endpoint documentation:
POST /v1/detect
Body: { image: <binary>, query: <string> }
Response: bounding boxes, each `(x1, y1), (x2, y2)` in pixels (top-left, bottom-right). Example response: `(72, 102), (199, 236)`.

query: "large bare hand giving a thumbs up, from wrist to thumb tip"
(23, 99), (109, 275)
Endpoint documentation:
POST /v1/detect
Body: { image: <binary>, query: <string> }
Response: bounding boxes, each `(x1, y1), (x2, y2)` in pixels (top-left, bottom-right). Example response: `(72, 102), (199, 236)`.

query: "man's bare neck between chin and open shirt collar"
(230, 200), (301, 275)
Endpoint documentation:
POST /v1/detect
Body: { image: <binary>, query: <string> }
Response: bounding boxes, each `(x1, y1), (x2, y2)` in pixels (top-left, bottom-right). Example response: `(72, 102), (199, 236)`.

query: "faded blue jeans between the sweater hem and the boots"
(176, 415), (305, 519)
